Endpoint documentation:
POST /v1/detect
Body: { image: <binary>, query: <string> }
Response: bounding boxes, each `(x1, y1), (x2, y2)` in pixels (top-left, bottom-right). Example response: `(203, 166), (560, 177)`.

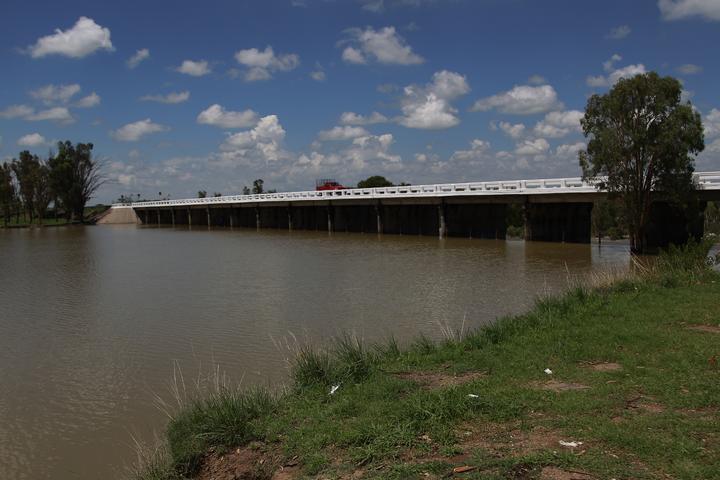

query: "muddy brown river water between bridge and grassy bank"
(0, 226), (628, 480)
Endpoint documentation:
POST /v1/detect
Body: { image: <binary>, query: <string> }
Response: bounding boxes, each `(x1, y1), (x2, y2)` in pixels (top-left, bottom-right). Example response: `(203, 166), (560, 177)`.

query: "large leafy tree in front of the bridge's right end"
(579, 72), (705, 253)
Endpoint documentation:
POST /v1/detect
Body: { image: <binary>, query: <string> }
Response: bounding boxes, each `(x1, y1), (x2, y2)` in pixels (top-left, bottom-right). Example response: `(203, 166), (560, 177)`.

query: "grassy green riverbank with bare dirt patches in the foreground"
(132, 245), (720, 479)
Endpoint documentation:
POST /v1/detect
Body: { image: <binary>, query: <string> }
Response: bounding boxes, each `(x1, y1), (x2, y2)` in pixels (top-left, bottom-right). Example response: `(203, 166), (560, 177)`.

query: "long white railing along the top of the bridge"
(113, 171), (720, 208)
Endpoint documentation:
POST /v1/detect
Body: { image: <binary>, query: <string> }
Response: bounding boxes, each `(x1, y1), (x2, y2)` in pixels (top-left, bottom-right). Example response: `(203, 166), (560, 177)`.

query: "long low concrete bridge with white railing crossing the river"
(104, 172), (720, 246)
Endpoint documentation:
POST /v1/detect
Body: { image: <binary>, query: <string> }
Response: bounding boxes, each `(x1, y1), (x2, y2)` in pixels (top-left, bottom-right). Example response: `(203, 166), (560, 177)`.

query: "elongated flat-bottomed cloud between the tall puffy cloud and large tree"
(470, 85), (562, 115)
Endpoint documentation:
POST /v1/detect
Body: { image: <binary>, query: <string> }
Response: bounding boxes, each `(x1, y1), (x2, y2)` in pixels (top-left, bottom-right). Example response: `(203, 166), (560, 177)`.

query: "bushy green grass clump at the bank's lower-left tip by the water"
(167, 388), (277, 474)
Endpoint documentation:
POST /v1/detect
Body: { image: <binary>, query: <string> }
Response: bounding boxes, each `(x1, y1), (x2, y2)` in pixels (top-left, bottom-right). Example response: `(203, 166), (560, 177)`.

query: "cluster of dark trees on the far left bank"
(0, 141), (104, 226)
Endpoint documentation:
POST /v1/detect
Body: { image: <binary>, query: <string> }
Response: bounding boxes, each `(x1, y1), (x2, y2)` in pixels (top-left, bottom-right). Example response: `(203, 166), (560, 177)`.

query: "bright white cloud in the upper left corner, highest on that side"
(29, 17), (115, 58)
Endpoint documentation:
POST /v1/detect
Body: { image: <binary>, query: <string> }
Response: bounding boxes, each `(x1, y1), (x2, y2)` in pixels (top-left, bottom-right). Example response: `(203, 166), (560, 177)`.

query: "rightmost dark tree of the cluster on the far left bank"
(48, 141), (105, 222)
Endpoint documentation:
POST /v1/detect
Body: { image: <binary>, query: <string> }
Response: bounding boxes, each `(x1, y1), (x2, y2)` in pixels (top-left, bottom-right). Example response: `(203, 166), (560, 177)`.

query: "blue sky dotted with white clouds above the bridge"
(0, 0), (720, 202)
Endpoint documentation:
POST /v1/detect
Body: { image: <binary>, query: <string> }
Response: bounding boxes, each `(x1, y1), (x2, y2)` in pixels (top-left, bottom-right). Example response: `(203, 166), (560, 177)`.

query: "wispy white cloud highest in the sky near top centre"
(342, 27), (425, 65)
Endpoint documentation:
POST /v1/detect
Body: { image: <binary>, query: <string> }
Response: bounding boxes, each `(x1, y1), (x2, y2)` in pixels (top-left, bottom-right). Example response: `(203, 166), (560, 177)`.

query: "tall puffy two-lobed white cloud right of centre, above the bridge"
(398, 70), (470, 130)
